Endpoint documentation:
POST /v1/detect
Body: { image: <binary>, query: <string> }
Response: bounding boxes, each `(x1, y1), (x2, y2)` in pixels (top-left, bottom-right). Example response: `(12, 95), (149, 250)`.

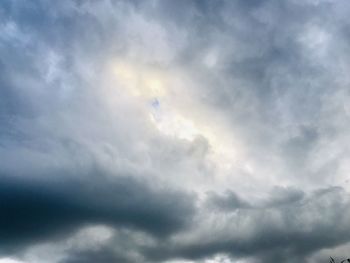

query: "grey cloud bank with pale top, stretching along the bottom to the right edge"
(56, 188), (350, 262)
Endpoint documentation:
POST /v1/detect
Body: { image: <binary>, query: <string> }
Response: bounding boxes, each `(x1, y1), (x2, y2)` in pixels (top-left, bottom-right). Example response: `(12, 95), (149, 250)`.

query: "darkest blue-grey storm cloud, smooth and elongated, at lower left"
(0, 173), (194, 253)
